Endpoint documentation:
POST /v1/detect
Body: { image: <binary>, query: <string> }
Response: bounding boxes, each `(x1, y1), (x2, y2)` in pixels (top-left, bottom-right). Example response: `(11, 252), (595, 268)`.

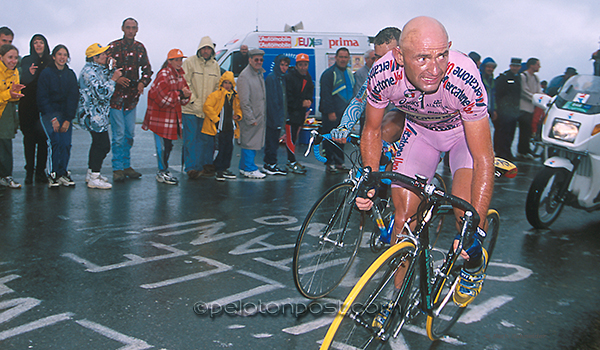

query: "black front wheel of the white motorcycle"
(525, 167), (569, 229)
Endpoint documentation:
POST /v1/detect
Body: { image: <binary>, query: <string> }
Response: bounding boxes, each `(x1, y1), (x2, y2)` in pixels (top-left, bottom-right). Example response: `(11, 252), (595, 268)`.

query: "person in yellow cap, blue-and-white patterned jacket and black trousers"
(77, 43), (122, 189)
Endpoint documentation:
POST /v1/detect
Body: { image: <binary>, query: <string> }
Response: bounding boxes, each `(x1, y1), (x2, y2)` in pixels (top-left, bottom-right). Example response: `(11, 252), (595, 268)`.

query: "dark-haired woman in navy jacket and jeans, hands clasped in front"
(37, 44), (79, 188)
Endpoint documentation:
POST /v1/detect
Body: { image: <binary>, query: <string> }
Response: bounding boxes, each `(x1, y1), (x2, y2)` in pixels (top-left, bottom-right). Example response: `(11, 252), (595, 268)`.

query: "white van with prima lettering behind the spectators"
(215, 32), (371, 116)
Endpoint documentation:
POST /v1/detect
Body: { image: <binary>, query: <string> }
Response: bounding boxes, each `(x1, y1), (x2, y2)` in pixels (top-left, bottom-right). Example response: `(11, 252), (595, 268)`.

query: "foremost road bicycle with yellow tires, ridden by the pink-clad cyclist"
(321, 171), (500, 349)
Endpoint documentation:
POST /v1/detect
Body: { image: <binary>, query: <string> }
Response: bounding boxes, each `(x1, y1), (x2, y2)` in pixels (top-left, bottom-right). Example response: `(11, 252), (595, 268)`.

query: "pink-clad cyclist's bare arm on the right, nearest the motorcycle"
(463, 118), (494, 228)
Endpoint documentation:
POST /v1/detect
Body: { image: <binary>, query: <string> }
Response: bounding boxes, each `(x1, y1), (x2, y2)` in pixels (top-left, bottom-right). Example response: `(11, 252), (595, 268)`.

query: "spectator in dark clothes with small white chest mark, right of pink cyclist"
(494, 58), (521, 160)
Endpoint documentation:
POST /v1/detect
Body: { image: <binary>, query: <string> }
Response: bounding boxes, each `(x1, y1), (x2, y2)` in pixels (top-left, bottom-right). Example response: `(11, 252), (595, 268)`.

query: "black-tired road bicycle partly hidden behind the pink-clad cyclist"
(292, 131), (451, 299)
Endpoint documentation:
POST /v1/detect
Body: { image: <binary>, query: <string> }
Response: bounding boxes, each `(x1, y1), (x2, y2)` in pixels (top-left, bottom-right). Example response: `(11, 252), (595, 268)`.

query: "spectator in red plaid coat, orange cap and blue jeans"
(142, 49), (192, 185)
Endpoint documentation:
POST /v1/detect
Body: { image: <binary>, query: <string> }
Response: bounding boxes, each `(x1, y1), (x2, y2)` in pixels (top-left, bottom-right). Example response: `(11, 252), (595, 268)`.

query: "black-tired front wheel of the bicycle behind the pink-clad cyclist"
(292, 183), (368, 299)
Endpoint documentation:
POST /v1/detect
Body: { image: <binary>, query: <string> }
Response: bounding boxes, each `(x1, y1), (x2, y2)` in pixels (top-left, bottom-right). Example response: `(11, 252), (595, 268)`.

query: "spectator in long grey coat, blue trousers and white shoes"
(238, 49), (267, 179)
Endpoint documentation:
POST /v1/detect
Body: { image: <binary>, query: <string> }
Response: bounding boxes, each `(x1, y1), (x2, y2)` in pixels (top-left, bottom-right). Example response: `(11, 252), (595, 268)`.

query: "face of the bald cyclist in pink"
(395, 33), (452, 93)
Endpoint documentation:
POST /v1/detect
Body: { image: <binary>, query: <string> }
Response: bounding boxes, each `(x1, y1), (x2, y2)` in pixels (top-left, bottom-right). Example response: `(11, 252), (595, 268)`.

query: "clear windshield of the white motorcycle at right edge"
(556, 74), (600, 114)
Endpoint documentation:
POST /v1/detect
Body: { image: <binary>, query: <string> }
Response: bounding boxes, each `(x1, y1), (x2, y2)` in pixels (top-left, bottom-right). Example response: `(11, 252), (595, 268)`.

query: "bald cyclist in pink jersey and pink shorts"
(356, 17), (494, 306)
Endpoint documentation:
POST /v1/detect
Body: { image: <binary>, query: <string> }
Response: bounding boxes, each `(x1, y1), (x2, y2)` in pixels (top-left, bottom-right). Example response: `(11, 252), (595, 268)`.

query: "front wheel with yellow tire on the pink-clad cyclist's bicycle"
(320, 242), (416, 350)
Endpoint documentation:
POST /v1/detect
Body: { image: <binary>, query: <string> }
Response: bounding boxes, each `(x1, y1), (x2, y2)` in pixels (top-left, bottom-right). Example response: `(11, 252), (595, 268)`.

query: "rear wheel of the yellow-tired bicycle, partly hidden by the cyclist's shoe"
(426, 209), (500, 340)
